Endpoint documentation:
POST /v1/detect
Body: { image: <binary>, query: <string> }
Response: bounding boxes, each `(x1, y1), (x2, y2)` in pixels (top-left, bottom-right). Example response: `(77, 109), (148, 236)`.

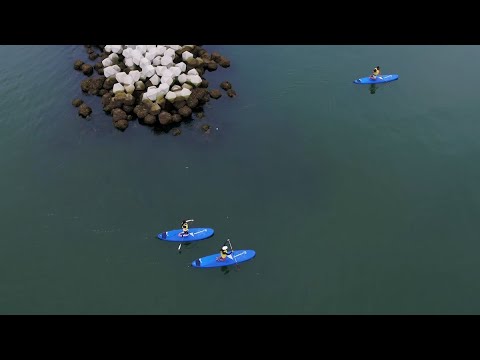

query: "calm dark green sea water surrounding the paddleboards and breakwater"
(0, 45), (480, 314)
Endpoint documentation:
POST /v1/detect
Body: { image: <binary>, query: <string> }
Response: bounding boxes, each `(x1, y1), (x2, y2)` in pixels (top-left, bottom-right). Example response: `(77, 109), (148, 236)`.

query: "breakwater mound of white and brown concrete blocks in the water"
(72, 45), (236, 135)
